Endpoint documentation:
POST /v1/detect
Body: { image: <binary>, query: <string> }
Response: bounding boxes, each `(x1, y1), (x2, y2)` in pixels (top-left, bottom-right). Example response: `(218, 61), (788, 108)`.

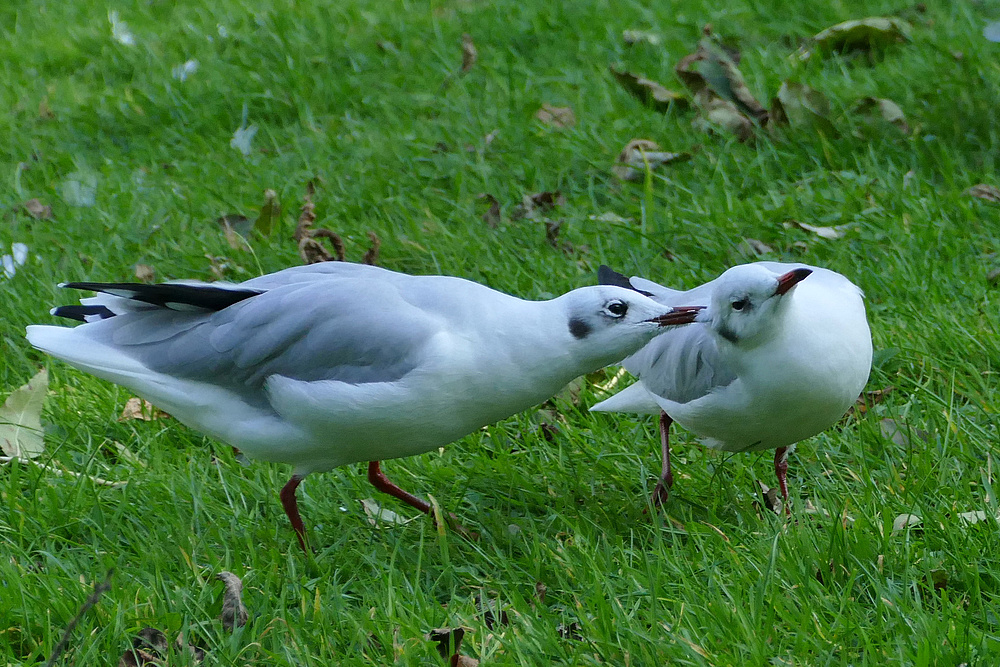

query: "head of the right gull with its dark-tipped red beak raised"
(698, 264), (812, 346)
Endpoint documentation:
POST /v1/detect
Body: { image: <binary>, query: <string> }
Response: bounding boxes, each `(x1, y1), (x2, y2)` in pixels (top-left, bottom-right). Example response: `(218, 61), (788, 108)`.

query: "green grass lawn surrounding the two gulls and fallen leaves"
(0, 0), (1000, 665)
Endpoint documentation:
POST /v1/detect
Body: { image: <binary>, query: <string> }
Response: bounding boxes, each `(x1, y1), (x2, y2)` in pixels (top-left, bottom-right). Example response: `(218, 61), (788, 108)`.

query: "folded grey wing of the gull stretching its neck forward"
(86, 271), (440, 388)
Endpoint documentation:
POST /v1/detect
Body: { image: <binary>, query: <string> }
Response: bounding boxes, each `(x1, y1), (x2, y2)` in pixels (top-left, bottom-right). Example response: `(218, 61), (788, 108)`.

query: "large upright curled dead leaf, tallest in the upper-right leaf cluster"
(674, 37), (768, 127)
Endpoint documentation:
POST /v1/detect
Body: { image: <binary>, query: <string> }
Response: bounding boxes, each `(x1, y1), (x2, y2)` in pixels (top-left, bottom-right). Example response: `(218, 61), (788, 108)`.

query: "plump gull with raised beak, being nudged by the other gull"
(591, 262), (872, 511)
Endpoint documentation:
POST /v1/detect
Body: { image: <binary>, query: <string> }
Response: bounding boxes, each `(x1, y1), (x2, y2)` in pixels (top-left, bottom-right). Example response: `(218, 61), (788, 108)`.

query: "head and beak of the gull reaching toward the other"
(558, 285), (701, 370)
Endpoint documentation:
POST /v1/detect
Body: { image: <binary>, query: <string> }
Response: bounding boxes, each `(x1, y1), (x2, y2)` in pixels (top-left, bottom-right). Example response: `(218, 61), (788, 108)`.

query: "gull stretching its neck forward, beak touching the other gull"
(27, 262), (697, 550)
